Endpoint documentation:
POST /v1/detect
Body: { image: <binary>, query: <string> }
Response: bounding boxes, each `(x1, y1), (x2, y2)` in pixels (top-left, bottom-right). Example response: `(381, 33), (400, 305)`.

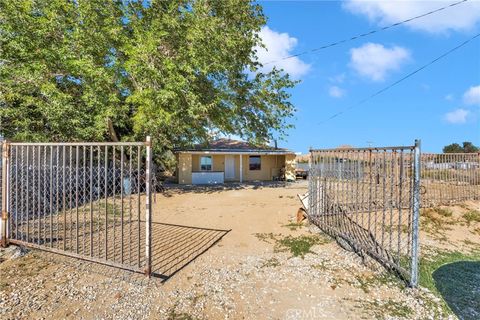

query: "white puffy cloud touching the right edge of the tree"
(255, 26), (310, 78)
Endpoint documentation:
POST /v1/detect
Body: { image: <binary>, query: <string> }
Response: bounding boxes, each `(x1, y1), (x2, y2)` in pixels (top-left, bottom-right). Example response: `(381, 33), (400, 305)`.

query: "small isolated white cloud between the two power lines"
(350, 43), (410, 81)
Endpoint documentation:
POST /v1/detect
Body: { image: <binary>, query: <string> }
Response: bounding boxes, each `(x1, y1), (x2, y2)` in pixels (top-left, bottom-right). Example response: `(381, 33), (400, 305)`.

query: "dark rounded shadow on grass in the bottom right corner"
(433, 261), (480, 320)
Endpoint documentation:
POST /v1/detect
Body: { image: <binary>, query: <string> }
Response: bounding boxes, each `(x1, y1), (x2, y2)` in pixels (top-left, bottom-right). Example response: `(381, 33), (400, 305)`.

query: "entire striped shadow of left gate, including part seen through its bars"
(8, 216), (230, 281)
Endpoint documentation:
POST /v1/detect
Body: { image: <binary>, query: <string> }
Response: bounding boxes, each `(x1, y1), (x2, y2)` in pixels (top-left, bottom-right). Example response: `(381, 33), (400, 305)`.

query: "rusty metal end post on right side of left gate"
(145, 136), (152, 277)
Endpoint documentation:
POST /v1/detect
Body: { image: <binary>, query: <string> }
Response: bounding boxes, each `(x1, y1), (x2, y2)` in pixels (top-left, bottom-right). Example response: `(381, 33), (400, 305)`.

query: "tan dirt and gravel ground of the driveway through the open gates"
(0, 181), (480, 319)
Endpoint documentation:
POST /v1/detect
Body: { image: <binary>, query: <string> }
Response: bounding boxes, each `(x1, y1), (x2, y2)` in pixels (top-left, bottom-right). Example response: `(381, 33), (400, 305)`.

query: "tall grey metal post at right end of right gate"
(410, 139), (421, 287)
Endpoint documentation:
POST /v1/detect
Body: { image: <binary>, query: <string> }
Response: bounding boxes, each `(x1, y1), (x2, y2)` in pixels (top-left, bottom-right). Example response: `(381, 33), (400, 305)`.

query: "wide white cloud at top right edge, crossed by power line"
(343, 0), (480, 33)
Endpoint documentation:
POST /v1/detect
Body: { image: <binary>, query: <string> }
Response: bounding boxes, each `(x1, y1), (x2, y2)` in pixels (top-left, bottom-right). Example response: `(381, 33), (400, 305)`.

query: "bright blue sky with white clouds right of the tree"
(259, 0), (480, 152)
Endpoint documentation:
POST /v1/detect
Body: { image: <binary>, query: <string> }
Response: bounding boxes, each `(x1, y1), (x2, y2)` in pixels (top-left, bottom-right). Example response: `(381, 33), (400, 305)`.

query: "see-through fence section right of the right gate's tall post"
(421, 153), (480, 207)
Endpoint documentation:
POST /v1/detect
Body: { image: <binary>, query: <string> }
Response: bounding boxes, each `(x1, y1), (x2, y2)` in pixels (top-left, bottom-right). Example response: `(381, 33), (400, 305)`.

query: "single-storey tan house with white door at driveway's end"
(175, 139), (295, 184)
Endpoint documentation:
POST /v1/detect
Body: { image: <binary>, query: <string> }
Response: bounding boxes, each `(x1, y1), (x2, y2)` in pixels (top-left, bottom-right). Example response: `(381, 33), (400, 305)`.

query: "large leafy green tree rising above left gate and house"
(0, 0), (295, 162)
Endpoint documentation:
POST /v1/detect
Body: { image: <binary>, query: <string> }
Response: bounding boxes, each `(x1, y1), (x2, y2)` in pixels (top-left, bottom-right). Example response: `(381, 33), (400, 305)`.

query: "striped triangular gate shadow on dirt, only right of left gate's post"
(152, 223), (230, 281)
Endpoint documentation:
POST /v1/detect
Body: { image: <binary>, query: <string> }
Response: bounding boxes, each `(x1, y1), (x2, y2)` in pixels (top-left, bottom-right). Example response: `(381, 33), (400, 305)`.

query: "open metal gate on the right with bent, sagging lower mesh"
(308, 141), (420, 286)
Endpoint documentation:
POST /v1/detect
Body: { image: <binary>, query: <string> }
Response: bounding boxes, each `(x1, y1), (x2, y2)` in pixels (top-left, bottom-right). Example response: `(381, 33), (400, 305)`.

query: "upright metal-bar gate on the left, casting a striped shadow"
(2, 137), (152, 275)
